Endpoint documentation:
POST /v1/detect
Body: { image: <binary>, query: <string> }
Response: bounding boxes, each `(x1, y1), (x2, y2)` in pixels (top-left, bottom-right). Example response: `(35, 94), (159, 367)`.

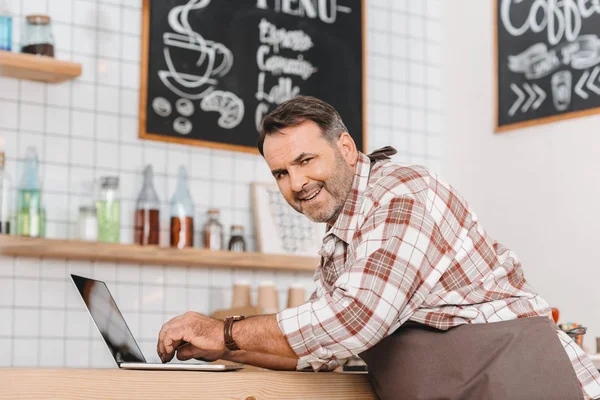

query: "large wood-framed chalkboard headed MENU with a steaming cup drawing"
(139, 0), (366, 152)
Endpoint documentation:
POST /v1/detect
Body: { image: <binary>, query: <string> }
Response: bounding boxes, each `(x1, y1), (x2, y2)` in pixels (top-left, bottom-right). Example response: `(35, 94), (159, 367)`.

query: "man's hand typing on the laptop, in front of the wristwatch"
(156, 311), (227, 363)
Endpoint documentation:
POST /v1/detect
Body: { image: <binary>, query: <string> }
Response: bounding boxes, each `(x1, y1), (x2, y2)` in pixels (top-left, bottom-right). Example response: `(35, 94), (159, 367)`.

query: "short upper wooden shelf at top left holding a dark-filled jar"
(0, 50), (81, 83)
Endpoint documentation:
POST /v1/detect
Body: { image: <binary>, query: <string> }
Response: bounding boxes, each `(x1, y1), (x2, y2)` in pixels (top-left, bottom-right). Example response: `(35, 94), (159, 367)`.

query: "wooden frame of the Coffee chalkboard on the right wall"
(492, 0), (600, 133)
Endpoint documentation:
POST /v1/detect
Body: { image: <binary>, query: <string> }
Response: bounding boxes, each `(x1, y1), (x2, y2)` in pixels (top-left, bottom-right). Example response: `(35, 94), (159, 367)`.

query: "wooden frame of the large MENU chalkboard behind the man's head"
(138, 0), (367, 154)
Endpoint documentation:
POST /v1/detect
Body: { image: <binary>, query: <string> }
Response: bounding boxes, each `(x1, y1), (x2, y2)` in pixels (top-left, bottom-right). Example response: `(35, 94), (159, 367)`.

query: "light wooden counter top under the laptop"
(0, 367), (375, 400)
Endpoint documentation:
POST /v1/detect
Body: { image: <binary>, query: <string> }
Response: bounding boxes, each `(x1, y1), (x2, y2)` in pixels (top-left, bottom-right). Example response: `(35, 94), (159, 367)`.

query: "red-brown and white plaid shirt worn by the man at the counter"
(277, 148), (600, 398)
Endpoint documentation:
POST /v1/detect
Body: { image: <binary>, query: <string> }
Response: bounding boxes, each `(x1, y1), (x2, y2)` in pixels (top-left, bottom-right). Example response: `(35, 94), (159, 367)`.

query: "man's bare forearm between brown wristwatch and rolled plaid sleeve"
(232, 314), (298, 360)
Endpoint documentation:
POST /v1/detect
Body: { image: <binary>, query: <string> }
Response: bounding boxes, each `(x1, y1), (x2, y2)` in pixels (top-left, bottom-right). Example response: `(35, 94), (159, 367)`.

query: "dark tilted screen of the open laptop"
(71, 274), (146, 364)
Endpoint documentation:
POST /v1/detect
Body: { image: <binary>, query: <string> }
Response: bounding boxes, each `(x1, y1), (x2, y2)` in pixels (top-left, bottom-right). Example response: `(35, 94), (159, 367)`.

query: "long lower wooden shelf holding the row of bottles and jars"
(0, 235), (319, 271)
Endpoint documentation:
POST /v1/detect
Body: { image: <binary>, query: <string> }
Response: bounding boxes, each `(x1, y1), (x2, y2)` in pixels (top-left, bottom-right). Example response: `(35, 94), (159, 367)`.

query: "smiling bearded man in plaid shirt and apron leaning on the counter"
(157, 97), (600, 400)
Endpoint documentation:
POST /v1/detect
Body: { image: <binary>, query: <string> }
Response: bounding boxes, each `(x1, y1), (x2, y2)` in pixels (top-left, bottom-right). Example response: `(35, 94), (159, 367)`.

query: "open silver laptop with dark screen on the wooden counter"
(71, 274), (244, 372)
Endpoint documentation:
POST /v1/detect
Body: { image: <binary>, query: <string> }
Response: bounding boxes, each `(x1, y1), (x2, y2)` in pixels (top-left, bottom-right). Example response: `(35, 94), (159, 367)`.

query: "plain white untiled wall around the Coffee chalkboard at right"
(442, 0), (600, 351)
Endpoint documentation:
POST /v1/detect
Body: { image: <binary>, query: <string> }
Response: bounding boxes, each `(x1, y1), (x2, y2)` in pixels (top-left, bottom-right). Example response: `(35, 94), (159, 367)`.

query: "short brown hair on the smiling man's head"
(258, 96), (348, 156)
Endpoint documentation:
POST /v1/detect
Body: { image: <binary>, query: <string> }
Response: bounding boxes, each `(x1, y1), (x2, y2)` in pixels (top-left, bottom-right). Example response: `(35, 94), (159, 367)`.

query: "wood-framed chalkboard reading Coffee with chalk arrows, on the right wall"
(495, 0), (600, 131)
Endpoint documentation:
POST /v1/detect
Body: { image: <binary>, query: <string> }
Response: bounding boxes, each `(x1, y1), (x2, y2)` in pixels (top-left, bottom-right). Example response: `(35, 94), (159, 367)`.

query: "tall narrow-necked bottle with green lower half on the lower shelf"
(17, 147), (46, 237)
